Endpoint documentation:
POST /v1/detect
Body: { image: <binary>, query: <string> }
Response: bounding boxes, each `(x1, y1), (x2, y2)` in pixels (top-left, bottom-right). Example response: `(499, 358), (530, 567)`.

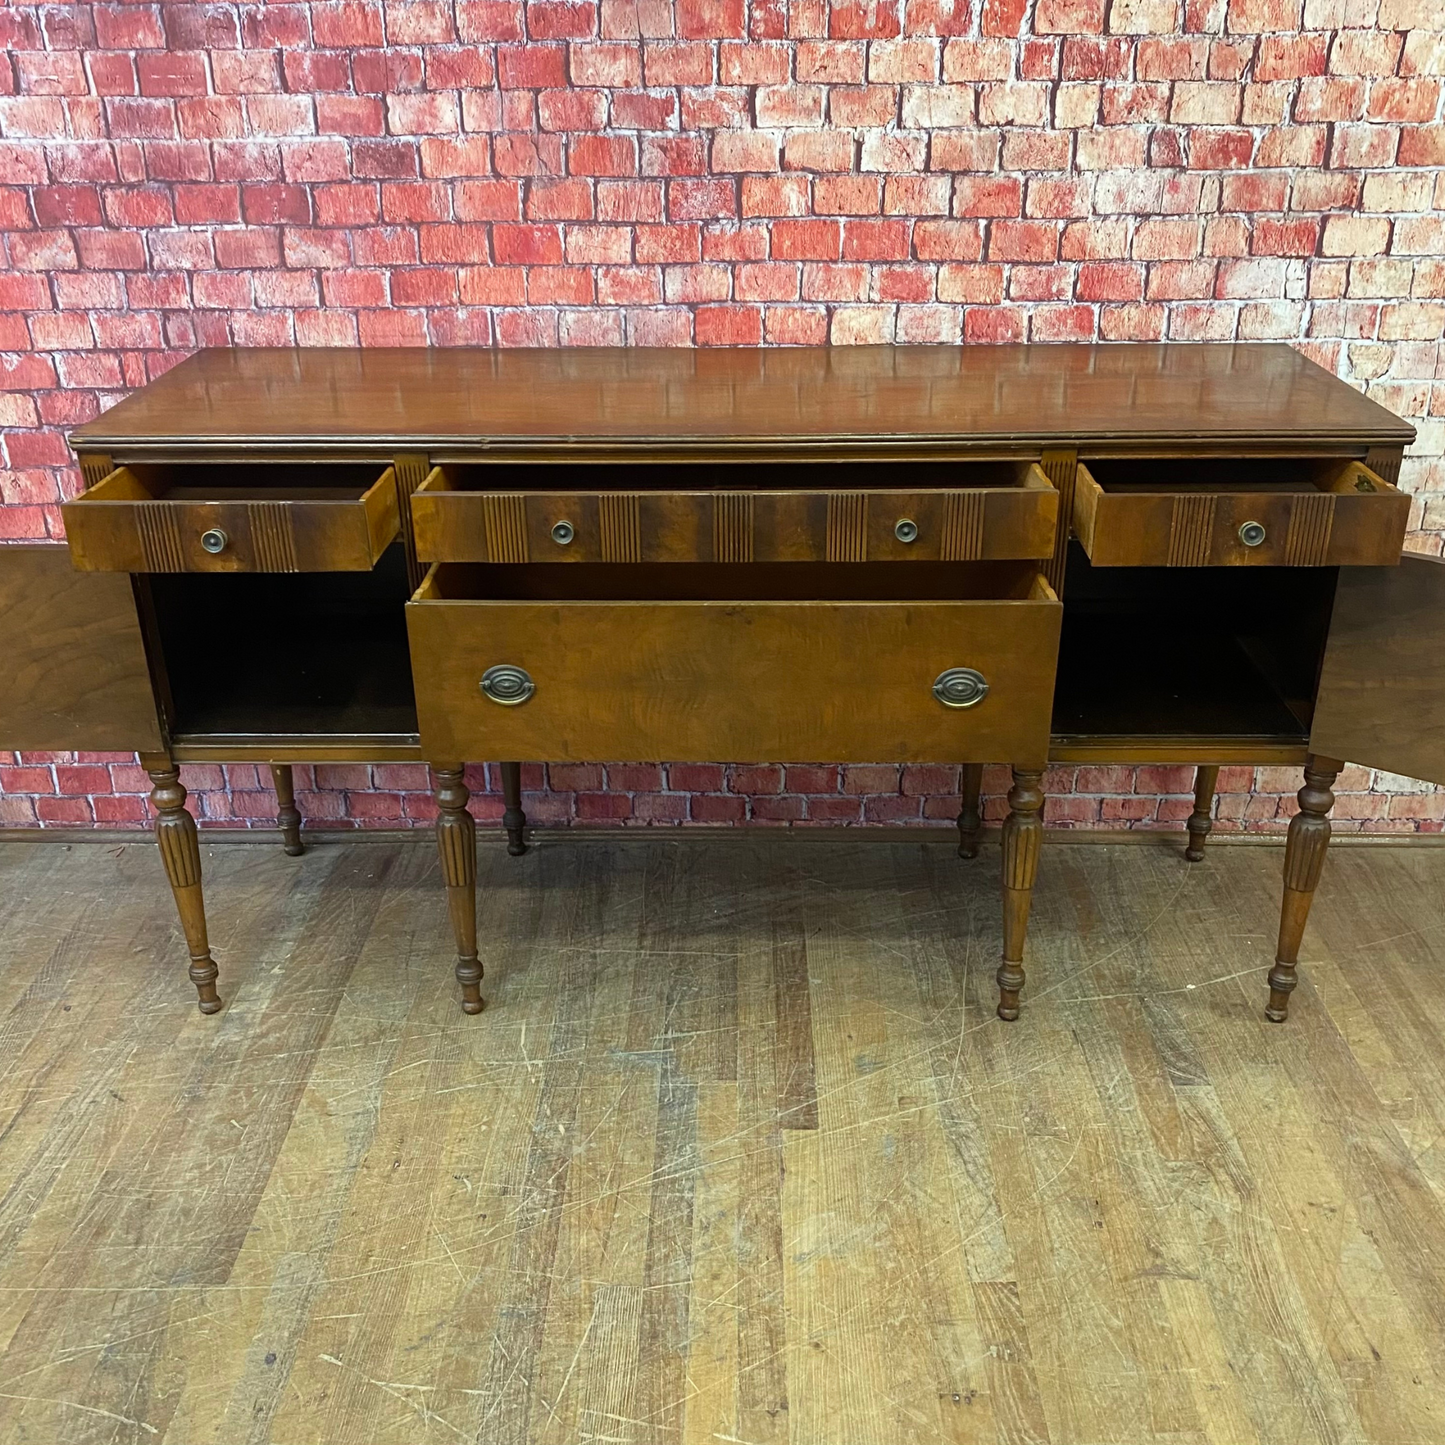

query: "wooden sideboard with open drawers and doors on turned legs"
(0, 345), (1445, 1020)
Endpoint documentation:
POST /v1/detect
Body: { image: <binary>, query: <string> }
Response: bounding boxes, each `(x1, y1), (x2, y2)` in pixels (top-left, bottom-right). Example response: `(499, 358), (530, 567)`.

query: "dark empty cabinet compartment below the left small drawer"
(145, 545), (416, 741)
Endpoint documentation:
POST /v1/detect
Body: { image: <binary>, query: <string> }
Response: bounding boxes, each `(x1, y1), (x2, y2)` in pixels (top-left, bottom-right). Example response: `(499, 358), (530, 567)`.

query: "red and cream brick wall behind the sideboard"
(0, 0), (1445, 828)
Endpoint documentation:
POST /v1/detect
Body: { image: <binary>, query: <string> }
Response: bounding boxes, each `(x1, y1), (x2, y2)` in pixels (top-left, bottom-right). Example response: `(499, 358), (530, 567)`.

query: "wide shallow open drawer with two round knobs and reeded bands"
(412, 461), (1059, 562)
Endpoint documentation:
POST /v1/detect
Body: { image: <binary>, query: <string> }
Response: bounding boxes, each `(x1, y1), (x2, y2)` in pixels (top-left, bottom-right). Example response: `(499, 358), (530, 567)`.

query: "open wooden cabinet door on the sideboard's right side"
(1309, 553), (1445, 783)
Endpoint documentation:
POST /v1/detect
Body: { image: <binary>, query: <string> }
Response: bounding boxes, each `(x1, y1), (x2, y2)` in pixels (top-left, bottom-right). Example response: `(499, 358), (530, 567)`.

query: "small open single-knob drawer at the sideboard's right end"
(1074, 457), (1410, 566)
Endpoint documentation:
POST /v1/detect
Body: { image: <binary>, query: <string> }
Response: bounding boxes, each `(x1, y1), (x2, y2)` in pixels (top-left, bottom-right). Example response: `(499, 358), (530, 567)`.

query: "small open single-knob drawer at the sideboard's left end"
(62, 464), (399, 572)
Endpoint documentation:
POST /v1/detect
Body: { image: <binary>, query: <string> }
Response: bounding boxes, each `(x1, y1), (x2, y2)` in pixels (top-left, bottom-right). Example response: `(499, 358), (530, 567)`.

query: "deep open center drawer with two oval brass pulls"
(406, 564), (1062, 766)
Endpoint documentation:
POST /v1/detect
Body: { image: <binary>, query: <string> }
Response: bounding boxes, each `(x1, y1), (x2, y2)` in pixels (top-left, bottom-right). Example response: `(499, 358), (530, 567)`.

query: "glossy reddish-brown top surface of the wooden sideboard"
(71, 342), (1415, 457)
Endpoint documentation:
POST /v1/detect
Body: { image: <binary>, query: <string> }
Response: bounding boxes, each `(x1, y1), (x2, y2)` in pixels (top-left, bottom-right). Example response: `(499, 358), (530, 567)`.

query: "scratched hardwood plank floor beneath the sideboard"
(0, 834), (1445, 1445)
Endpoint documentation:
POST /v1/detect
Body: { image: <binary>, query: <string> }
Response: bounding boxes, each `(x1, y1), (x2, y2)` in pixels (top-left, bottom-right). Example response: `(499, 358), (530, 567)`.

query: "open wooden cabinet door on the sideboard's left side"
(0, 543), (165, 753)
